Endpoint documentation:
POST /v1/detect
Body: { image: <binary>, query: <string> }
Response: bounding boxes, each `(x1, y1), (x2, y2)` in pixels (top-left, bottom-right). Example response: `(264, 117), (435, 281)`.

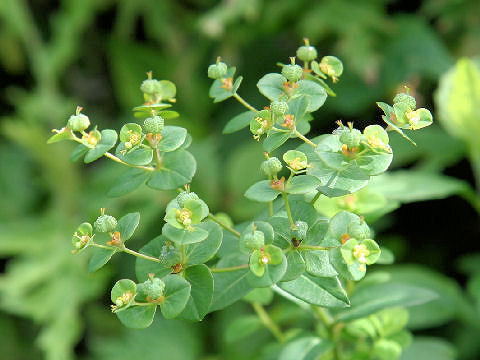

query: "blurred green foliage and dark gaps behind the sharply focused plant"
(0, 0), (480, 360)
